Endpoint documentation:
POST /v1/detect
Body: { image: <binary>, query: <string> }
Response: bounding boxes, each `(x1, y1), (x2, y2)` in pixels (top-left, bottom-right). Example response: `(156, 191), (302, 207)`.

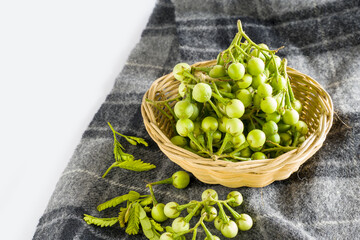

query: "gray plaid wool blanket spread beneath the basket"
(34, 0), (360, 239)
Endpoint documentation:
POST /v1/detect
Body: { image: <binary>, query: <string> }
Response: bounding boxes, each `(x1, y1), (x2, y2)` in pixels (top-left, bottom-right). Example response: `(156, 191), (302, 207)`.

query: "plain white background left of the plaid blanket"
(0, 0), (155, 239)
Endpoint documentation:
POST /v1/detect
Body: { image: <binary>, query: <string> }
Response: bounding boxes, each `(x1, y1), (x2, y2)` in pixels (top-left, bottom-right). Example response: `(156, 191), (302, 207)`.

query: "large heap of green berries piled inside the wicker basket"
(166, 20), (308, 161)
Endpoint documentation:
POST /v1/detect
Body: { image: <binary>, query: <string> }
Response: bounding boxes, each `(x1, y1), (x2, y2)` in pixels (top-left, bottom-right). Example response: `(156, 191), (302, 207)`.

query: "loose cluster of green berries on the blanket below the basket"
(160, 189), (253, 240)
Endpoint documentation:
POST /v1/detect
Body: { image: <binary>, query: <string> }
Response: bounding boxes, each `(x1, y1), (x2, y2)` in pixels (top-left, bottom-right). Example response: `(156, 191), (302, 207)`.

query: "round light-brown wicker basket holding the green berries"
(141, 60), (333, 188)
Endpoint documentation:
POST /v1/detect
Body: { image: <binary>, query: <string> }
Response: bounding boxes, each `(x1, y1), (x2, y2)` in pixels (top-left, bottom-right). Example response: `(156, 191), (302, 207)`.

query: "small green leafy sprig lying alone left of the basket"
(102, 122), (156, 178)
